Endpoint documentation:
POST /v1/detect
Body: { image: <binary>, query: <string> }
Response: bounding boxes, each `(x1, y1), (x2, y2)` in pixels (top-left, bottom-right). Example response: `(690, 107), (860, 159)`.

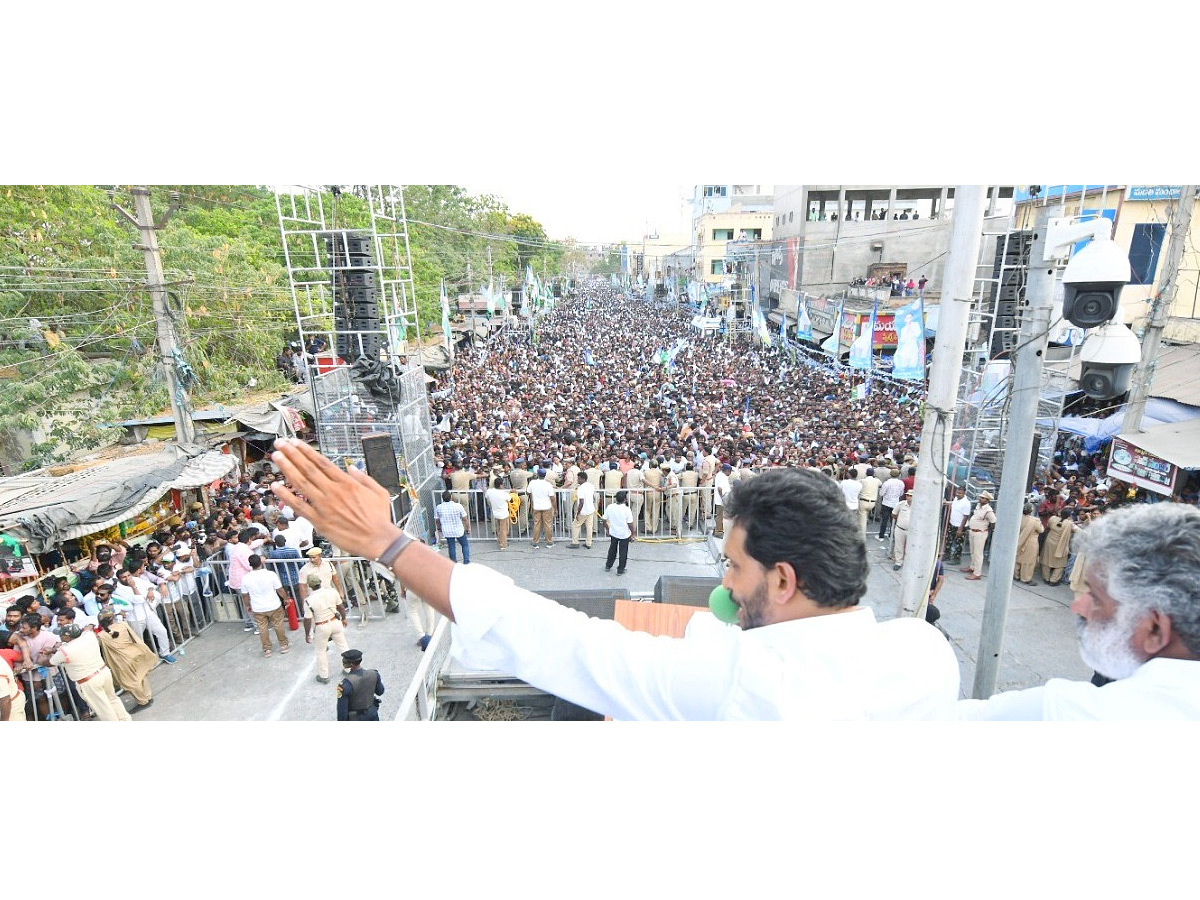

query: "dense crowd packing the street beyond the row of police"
(432, 284), (922, 533)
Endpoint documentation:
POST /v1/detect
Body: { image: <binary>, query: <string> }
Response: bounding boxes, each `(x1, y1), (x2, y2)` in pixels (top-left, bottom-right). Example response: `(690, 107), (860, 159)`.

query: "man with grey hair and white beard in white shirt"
(958, 503), (1200, 721)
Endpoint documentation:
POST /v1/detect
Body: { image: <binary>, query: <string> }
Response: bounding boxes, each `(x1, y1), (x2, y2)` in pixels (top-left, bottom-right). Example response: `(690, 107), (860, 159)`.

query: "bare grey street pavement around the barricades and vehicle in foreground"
(127, 533), (1092, 721)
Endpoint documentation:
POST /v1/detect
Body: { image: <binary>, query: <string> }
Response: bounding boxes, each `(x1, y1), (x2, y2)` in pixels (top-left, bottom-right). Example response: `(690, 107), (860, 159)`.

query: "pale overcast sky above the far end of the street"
(461, 176), (692, 244)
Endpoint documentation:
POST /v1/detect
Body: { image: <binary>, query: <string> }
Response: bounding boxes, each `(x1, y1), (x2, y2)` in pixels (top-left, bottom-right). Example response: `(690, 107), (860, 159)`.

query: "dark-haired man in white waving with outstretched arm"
(271, 439), (959, 720)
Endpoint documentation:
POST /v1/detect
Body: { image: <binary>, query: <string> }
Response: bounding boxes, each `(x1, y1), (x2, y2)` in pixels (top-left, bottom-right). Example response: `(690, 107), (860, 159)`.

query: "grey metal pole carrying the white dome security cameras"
(971, 210), (1058, 700)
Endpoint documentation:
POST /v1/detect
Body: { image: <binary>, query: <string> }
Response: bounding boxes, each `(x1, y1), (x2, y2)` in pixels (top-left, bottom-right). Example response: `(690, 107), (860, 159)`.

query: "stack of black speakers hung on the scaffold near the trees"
(325, 232), (383, 362)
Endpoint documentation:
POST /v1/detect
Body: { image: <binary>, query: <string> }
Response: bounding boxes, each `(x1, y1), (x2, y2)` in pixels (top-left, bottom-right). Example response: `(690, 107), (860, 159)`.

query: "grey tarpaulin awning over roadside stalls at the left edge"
(0, 446), (236, 553)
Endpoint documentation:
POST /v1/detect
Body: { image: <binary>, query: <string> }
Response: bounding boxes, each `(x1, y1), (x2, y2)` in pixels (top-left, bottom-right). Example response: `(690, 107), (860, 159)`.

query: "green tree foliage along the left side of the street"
(0, 185), (562, 468)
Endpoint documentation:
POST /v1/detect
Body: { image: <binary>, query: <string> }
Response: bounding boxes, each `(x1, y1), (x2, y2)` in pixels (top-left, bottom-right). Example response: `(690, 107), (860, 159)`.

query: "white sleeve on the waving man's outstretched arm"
(450, 565), (739, 720)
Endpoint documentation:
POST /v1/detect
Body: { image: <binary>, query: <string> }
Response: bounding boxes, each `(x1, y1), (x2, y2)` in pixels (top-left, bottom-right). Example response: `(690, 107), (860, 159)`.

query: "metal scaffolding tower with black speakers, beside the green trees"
(275, 185), (440, 539)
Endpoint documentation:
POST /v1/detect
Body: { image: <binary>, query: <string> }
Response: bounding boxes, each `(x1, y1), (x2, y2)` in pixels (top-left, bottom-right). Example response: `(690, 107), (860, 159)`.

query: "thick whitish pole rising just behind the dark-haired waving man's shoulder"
(899, 185), (986, 616)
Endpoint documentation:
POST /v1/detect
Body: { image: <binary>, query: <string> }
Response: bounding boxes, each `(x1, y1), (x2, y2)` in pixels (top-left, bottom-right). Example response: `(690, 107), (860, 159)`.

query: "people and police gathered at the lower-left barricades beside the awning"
(0, 472), (348, 720)
